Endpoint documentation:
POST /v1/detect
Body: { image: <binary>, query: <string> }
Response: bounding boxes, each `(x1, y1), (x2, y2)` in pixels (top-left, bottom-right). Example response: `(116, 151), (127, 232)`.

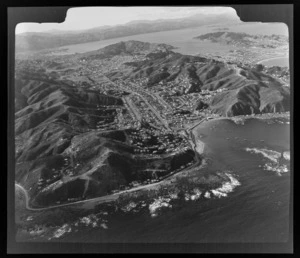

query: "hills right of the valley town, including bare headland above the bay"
(105, 47), (290, 116)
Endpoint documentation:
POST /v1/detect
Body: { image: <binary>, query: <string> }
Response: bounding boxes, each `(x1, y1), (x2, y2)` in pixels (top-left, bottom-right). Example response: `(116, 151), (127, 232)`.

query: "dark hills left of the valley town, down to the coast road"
(15, 74), (194, 206)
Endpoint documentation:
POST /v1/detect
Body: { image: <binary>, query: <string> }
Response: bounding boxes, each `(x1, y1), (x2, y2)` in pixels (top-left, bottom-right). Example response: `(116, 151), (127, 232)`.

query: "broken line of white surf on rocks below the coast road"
(42, 171), (241, 240)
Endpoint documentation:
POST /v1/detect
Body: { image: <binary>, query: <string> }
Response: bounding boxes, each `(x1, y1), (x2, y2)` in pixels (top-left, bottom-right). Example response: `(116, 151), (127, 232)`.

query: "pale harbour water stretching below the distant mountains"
(53, 23), (288, 55)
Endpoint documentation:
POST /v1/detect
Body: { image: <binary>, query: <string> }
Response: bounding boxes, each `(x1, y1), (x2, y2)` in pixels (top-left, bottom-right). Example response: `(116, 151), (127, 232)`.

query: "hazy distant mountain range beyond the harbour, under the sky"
(16, 14), (240, 51)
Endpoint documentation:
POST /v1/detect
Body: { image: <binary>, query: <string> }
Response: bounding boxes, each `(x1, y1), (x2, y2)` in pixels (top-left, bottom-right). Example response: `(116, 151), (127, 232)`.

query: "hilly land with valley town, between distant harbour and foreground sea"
(15, 41), (290, 206)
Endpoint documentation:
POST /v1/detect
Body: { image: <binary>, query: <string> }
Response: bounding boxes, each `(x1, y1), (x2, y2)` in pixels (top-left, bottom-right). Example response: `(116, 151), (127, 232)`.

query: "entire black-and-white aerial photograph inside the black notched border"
(9, 5), (293, 252)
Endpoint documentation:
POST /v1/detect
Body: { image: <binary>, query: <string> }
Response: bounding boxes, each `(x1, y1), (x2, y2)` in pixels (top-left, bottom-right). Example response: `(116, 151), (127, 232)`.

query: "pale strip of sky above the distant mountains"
(16, 7), (236, 34)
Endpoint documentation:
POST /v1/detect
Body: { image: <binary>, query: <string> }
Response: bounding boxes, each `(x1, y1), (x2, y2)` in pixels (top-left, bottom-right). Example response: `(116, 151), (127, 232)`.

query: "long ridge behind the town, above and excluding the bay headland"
(113, 51), (279, 90)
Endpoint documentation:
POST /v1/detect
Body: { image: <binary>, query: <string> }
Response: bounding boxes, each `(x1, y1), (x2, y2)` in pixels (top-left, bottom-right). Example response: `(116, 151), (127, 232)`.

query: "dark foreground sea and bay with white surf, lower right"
(43, 119), (290, 243)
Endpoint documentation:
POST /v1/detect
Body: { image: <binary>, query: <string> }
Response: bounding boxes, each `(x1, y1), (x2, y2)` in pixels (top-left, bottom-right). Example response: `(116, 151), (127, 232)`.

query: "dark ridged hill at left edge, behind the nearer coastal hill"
(15, 80), (123, 134)
